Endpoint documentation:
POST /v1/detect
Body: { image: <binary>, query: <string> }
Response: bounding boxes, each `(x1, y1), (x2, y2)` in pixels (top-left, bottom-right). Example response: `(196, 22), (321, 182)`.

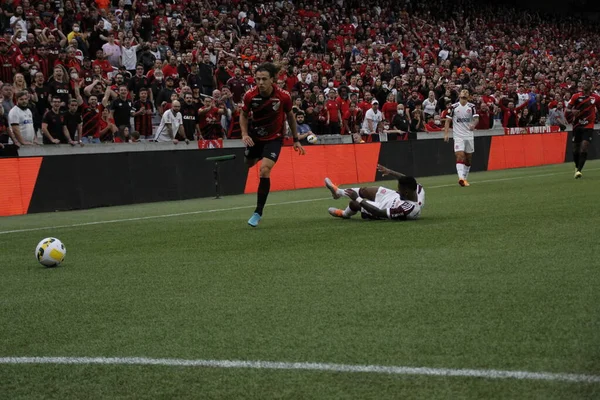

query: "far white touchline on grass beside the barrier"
(0, 168), (600, 235)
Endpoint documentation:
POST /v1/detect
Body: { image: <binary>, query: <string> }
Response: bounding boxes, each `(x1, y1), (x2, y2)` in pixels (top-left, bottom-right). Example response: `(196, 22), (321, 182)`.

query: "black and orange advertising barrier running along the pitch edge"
(0, 132), (600, 216)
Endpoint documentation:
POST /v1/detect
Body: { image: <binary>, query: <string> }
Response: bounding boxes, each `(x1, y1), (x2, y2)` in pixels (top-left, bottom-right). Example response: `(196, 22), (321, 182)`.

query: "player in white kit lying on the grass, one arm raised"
(325, 165), (425, 221)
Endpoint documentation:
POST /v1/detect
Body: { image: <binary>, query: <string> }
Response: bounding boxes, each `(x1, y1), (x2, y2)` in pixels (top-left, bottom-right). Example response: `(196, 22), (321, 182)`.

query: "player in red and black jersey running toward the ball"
(240, 63), (304, 227)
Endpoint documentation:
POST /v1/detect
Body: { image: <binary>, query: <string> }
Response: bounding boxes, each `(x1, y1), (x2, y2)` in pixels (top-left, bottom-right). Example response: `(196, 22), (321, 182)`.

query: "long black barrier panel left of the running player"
(23, 148), (246, 213)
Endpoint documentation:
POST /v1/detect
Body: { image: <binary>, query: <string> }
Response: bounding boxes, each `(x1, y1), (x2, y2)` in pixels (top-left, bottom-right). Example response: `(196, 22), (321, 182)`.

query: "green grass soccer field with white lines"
(0, 161), (600, 399)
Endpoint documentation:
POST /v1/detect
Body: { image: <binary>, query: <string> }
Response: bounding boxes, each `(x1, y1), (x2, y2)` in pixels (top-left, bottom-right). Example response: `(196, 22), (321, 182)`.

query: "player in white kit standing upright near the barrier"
(444, 90), (479, 186)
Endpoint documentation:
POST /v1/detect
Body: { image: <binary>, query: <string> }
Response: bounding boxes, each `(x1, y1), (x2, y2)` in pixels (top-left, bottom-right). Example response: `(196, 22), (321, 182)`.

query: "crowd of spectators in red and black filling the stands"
(0, 0), (600, 144)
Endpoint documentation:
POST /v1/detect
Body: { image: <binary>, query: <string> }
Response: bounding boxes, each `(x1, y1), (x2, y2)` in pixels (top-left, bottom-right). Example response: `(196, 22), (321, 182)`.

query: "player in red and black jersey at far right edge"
(567, 80), (600, 179)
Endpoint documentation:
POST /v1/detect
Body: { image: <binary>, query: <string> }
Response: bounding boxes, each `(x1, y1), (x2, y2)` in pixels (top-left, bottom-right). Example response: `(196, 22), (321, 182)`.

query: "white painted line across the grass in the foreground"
(0, 357), (600, 383)
